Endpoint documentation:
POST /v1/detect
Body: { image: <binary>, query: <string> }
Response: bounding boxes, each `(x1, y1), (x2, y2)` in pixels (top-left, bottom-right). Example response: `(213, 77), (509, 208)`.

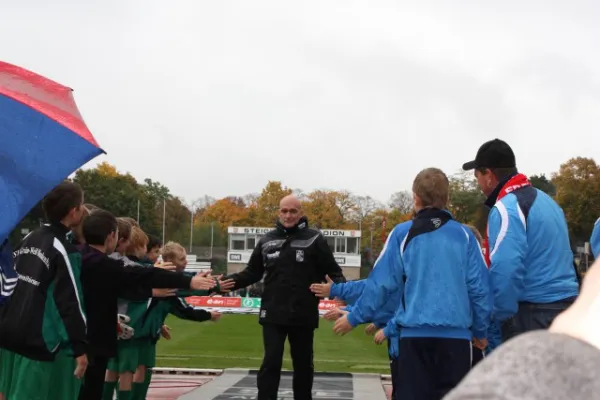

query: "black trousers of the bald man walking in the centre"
(256, 323), (315, 400)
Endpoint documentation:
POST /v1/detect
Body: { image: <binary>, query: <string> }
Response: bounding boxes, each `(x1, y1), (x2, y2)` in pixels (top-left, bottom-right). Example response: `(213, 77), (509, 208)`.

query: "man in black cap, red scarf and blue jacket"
(463, 139), (579, 341)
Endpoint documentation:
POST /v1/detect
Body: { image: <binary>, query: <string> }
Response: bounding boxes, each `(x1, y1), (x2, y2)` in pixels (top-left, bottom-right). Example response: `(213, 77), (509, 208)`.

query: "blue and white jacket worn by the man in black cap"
(488, 186), (579, 321)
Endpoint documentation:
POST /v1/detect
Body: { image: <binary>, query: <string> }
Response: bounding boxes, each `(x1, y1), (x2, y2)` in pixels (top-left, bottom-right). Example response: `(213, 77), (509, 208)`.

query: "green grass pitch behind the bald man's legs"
(156, 314), (389, 373)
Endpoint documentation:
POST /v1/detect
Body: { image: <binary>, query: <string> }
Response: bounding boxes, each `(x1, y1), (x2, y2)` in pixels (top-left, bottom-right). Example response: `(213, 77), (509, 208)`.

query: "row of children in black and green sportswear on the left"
(0, 182), (225, 400)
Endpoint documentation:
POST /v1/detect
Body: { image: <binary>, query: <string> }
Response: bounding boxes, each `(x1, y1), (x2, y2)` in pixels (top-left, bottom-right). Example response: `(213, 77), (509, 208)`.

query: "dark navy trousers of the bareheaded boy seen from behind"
(396, 338), (471, 400)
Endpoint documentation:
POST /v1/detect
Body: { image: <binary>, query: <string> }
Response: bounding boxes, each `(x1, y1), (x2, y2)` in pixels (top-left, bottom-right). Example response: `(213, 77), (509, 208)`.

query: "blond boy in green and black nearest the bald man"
(132, 242), (221, 400)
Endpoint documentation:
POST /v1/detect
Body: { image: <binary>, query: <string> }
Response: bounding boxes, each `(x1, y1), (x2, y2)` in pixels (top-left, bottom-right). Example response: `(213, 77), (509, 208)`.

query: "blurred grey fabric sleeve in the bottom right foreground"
(444, 331), (600, 400)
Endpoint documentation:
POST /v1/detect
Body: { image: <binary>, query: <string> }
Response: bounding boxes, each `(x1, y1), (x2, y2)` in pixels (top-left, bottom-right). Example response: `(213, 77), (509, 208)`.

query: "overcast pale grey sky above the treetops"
(0, 0), (600, 201)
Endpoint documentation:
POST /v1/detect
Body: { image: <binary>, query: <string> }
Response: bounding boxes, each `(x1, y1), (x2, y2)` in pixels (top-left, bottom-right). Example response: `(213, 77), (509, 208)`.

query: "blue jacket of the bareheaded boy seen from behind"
(348, 209), (492, 340)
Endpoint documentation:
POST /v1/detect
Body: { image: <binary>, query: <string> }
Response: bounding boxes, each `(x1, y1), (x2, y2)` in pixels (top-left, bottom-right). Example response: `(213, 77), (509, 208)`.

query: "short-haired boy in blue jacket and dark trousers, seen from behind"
(334, 168), (493, 400)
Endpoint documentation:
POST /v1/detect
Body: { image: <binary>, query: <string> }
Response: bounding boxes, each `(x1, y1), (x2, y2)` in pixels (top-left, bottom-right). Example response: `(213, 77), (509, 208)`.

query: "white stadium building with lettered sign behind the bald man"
(227, 226), (361, 280)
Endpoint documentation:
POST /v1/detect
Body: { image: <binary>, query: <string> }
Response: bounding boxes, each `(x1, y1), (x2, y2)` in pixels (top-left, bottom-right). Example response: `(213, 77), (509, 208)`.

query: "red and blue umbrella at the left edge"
(0, 61), (103, 242)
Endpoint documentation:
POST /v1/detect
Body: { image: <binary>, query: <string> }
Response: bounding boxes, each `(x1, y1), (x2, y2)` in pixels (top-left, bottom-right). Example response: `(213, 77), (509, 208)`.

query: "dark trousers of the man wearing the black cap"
(500, 297), (575, 343)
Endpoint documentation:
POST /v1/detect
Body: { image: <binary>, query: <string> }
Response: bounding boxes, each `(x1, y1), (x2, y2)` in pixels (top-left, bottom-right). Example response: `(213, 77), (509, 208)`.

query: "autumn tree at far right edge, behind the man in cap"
(552, 157), (600, 242)
